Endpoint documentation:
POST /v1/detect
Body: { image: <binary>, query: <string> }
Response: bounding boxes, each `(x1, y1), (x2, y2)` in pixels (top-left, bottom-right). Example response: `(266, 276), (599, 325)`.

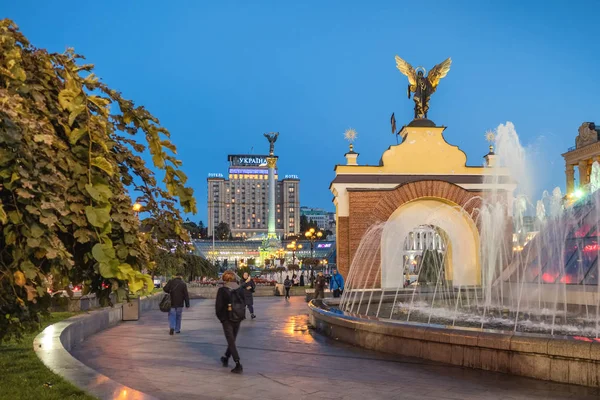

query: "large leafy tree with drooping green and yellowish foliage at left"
(0, 19), (196, 340)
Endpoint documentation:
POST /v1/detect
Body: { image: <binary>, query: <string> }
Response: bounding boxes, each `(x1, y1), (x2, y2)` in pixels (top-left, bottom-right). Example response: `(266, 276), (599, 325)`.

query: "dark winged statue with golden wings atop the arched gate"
(396, 56), (452, 119)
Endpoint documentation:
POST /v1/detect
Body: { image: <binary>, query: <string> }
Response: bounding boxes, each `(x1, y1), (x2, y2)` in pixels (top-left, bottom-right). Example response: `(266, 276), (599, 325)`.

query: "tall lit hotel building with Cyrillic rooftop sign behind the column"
(207, 154), (300, 239)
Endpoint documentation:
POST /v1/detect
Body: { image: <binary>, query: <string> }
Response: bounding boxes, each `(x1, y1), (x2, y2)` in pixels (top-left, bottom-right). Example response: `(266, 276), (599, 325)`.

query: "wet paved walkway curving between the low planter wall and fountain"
(72, 297), (598, 400)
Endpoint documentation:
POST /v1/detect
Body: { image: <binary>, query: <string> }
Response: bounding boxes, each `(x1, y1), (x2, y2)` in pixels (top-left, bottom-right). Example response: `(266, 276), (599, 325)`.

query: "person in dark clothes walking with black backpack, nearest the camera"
(215, 271), (246, 374)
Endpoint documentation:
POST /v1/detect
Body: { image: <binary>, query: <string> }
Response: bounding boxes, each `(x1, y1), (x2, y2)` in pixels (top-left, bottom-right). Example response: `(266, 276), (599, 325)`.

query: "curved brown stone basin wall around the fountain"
(309, 299), (600, 387)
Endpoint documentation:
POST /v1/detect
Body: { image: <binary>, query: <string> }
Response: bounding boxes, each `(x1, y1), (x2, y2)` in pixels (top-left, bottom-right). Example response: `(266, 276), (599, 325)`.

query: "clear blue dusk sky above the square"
(0, 0), (600, 222)
